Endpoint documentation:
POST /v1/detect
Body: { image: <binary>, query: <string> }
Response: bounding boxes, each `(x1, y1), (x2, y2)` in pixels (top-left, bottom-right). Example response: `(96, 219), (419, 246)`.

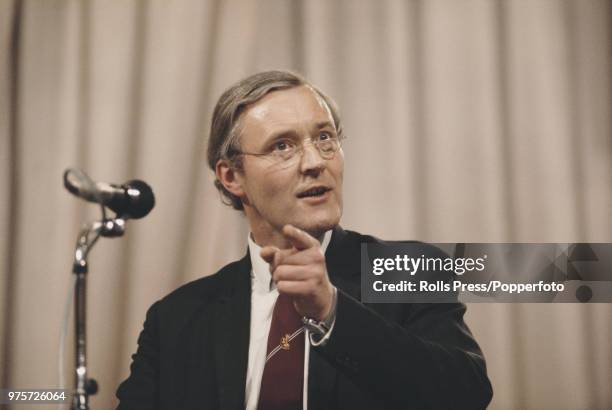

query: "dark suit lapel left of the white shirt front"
(213, 252), (251, 409)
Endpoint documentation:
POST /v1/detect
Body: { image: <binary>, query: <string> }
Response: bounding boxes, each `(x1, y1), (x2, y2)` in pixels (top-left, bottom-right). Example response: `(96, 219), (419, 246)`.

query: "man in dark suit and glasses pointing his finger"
(117, 71), (492, 409)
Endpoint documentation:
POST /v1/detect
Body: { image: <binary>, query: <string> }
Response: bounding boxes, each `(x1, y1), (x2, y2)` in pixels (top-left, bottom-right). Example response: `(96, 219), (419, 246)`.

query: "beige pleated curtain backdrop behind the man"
(0, 0), (612, 410)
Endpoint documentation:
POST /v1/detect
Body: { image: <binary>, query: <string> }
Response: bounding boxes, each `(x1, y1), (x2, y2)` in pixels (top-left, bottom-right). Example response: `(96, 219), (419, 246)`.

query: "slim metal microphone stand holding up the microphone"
(72, 216), (125, 410)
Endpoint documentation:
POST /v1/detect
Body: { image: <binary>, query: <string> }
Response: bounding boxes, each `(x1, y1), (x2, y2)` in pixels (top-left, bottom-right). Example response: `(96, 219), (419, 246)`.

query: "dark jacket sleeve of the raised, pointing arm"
(317, 290), (493, 409)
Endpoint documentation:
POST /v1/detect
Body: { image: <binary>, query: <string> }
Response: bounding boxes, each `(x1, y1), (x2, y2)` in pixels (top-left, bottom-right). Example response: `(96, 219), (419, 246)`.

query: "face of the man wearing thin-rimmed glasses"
(236, 86), (344, 242)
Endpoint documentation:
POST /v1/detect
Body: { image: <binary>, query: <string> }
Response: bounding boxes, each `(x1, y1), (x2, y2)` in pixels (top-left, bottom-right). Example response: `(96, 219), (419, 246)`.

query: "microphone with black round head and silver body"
(64, 168), (155, 219)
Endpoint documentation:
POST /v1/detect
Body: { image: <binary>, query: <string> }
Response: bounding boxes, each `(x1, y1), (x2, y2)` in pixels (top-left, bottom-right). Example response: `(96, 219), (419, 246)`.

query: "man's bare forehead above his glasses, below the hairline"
(241, 86), (333, 144)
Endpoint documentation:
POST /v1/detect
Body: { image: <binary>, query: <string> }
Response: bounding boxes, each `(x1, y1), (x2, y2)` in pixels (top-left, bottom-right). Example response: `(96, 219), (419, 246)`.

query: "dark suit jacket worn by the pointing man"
(117, 227), (492, 410)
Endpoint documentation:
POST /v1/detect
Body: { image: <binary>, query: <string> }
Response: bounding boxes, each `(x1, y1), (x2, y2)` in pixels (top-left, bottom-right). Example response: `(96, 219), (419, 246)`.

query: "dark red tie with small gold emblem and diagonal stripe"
(257, 295), (304, 410)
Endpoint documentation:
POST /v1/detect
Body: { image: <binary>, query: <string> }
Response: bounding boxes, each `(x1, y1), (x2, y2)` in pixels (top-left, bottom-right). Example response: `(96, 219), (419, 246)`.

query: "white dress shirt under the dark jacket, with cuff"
(245, 230), (333, 410)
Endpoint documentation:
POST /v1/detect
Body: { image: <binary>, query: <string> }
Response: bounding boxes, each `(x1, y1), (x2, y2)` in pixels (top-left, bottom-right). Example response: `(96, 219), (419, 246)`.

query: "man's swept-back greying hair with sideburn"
(207, 70), (342, 210)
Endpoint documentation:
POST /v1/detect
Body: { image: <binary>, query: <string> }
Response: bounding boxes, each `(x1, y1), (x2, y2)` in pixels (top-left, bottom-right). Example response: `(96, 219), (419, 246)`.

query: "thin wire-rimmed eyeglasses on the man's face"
(237, 131), (345, 163)
